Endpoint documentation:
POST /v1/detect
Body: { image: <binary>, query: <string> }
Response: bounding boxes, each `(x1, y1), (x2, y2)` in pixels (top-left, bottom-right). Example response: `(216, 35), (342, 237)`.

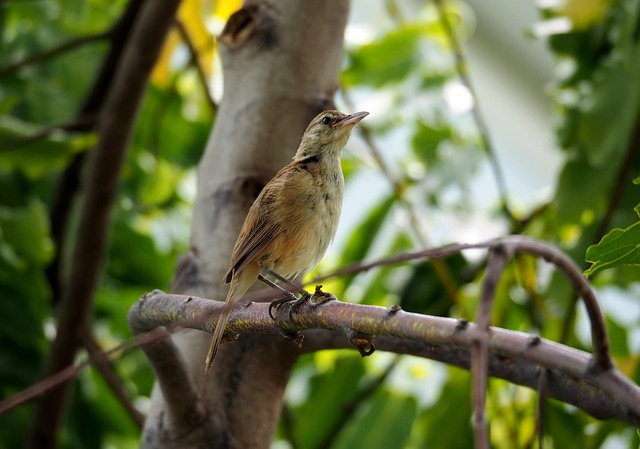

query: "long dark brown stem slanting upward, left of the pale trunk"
(29, 0), (180, 449)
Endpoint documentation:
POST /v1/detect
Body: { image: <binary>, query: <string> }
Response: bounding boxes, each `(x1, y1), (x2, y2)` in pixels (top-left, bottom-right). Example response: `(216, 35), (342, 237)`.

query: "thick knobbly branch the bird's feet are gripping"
(129, 292), (640, 425)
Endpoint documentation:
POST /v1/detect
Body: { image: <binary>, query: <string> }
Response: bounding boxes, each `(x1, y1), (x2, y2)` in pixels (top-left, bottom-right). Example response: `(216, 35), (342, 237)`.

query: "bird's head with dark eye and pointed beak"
(294, 110), (369, 160)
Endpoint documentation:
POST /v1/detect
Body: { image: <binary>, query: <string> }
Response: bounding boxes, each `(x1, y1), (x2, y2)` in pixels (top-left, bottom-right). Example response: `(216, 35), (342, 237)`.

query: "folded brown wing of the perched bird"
(224, 191), (277, 283)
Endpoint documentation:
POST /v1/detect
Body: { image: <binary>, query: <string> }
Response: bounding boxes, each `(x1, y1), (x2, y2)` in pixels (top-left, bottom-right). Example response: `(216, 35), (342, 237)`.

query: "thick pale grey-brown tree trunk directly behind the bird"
(142, 0), (349, 448)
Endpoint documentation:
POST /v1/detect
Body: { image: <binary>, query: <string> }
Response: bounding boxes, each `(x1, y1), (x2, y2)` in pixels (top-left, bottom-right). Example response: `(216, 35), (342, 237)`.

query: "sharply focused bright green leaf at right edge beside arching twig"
(584, 215), (640, 276)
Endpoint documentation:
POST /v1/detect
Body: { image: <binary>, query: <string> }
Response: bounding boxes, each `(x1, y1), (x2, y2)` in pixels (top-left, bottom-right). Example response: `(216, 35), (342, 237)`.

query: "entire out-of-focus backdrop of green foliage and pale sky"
(0, 0), (640, 449)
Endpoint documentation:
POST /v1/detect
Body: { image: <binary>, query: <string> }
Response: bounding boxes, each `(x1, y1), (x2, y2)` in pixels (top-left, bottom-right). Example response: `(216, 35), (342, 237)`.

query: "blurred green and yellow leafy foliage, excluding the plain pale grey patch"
(0, 0), (640, 449)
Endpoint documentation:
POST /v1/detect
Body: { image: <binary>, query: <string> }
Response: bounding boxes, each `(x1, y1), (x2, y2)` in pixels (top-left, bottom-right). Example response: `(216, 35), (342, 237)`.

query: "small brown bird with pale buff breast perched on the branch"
(205, 111), (369, 373)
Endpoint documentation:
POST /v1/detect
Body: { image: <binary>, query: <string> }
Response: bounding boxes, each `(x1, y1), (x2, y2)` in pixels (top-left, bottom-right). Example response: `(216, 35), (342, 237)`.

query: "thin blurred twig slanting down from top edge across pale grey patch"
(435, 0), (515, 222)
